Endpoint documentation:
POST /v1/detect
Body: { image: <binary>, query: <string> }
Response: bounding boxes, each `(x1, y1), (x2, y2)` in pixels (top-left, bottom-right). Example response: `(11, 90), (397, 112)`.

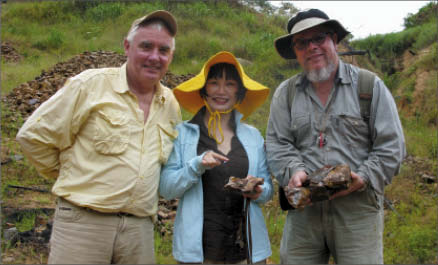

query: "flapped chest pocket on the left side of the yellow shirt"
(93, 110), (130, 155)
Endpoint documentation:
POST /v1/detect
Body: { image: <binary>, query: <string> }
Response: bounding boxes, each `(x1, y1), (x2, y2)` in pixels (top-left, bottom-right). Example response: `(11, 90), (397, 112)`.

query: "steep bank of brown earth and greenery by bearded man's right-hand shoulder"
(351, 2), (438, 159)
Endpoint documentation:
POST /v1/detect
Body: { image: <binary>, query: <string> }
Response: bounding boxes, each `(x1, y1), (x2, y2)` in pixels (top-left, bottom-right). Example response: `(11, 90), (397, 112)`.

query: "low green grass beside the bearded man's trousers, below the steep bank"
(384, 163), (438, 264)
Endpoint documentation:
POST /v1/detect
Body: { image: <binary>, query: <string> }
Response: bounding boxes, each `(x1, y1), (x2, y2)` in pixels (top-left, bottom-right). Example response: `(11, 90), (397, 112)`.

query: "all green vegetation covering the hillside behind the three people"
(1, 0), (438, 264)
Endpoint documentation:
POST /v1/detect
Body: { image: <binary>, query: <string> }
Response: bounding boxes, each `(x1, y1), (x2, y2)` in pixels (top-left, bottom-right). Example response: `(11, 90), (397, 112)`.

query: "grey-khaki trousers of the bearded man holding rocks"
(280, 189), (384, 264)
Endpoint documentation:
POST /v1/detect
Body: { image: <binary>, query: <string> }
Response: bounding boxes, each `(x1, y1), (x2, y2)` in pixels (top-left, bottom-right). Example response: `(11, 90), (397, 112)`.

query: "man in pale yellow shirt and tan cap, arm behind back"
(17, 10), (181, 264)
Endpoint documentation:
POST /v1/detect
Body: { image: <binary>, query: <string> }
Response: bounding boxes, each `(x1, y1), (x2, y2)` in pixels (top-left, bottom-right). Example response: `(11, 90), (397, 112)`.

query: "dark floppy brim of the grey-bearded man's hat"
(274, 19), (350, 59)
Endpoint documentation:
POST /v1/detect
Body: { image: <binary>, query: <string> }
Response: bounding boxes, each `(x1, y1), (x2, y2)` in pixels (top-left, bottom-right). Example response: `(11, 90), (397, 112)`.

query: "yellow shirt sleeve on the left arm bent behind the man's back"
(16, 79), (87, 178)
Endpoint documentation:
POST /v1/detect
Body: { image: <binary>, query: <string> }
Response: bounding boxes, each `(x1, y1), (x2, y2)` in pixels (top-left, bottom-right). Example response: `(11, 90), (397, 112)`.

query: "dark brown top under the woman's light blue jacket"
(190, 107), (249, 263)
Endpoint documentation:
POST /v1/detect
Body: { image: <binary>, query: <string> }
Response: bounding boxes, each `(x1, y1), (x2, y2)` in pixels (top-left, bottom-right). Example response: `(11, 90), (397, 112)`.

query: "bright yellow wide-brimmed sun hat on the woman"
(173, 51), (269, 119)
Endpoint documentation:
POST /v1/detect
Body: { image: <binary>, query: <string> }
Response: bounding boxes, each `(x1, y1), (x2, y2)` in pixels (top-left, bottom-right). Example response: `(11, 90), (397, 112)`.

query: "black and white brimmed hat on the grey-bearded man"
(274, 9), (350, 59)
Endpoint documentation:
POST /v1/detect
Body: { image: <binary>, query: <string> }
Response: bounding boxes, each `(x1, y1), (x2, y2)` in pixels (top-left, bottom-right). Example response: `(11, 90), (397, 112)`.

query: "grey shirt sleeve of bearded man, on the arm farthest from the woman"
(357, 78), (406, 194)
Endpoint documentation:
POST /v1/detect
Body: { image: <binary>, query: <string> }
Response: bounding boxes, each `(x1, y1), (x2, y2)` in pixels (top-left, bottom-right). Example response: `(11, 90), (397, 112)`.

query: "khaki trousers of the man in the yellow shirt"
(48, 198), (155, 264)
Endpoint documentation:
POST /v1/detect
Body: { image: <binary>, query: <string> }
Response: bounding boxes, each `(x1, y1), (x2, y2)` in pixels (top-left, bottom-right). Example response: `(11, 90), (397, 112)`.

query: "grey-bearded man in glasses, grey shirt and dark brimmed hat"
(266, 9), (406, 264)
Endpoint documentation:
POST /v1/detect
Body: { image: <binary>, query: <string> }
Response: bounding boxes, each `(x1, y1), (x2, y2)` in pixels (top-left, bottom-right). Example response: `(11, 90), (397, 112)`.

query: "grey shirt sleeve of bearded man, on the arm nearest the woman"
(266, 80), (306, 186)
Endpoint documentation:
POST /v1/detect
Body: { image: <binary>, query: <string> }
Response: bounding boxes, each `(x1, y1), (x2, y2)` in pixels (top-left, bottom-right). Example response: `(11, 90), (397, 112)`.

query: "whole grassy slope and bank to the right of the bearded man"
(351, 2), (438, 264)
